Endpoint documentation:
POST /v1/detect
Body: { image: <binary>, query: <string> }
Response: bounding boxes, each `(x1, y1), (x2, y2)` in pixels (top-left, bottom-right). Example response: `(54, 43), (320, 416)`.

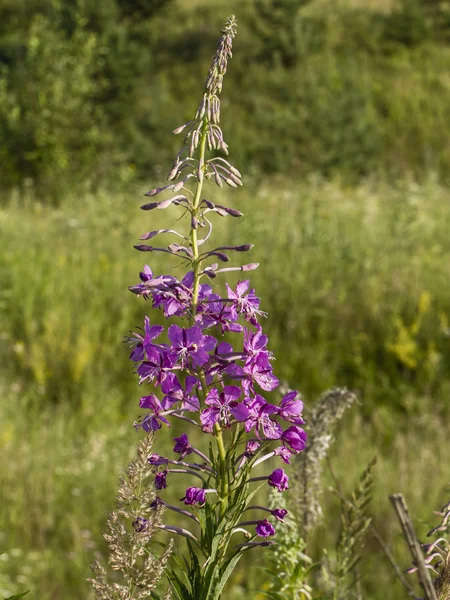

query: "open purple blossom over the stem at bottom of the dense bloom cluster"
(200, 385), (249, 433)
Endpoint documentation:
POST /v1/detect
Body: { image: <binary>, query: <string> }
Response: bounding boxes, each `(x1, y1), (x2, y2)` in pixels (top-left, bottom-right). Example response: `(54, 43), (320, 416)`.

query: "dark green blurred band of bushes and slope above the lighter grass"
(0, 0), (450, 193)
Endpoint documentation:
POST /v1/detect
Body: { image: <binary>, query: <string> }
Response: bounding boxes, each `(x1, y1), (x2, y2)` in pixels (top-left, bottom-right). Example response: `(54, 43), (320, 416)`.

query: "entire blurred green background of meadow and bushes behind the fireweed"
(0, 0), (450, 600)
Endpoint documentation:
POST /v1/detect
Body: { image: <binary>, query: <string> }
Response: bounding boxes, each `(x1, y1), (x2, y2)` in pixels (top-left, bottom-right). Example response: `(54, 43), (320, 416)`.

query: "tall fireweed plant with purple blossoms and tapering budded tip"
(127, 16), (306, 600)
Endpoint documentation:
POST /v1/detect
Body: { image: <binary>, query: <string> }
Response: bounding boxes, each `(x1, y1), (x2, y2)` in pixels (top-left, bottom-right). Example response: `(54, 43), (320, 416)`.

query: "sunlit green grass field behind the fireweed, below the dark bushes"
(0, 178), (450, 600)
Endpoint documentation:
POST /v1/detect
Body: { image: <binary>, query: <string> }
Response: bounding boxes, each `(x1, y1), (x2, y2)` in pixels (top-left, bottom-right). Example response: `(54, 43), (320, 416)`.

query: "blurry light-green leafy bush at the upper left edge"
(0, 15), (111, 194)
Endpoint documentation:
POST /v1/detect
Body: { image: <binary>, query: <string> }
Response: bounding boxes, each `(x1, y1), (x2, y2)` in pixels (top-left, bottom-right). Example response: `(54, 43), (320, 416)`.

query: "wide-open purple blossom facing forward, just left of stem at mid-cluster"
(168, 325), (216, 368)
